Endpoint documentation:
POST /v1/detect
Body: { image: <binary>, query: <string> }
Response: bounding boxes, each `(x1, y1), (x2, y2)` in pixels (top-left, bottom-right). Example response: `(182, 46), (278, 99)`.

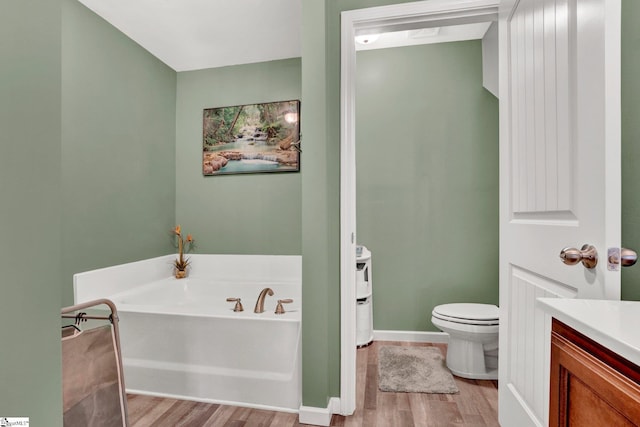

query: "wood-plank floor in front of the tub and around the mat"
(128, 341), (499, 427)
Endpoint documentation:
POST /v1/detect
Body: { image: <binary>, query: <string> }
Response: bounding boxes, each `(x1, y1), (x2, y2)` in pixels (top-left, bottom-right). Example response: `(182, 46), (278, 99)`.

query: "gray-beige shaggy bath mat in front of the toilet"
(378, 346), (458, 394)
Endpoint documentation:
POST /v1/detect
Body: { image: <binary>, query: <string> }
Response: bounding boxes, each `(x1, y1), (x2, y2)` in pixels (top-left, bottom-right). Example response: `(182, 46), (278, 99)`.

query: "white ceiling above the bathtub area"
(79, 0), (302, 71)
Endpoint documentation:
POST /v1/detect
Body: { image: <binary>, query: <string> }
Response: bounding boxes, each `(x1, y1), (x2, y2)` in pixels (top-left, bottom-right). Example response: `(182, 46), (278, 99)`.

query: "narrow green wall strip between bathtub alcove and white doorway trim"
(301, 0), (416, 407)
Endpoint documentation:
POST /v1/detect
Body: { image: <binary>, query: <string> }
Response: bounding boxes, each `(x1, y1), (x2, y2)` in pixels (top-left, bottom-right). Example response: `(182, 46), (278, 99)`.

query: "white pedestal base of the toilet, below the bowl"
(447, 335), (498, 380)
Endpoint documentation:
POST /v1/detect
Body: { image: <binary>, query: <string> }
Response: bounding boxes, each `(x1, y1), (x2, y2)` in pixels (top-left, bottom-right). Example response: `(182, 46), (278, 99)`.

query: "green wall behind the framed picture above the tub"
(175, 58), (302, 255)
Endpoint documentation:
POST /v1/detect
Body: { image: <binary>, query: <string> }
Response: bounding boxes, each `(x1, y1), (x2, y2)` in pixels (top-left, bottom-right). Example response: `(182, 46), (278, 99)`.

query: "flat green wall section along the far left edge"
(0, 0), (62, 427)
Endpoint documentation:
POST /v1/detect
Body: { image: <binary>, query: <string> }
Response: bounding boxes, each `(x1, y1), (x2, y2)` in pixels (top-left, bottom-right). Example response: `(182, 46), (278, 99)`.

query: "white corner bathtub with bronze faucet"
(74, 255), (302, 412)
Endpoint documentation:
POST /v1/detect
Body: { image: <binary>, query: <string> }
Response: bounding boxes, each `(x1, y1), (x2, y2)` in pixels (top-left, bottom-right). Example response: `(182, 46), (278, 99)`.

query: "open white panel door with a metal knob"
(499, 0), (620, 427)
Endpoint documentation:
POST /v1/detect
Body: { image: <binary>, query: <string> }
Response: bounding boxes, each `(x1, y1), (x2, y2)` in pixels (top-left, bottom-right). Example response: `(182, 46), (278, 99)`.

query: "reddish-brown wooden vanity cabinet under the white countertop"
(549, 319), (640, 427)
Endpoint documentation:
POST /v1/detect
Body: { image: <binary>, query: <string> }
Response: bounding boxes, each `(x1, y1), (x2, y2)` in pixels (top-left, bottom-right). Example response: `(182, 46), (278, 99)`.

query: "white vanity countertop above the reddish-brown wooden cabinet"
(538, 298), (640, 365)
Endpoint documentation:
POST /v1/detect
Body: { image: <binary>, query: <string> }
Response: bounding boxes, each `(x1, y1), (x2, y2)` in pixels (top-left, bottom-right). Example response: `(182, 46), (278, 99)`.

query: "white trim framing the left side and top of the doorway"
(340, 0), (500, 415)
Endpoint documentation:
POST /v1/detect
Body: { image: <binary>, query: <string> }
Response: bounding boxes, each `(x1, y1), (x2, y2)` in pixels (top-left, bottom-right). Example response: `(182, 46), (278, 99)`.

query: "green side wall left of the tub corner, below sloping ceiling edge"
(62, 0), (176, 305)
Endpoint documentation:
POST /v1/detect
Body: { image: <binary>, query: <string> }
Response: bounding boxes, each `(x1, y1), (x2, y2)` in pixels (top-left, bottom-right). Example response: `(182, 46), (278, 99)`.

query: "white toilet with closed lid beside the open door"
(431, 304), (499, 380)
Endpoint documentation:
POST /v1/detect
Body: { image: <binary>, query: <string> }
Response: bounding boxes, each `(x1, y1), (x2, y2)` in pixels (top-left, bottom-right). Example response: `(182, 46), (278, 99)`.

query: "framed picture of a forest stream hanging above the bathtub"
(202, 100), (300, 176)
